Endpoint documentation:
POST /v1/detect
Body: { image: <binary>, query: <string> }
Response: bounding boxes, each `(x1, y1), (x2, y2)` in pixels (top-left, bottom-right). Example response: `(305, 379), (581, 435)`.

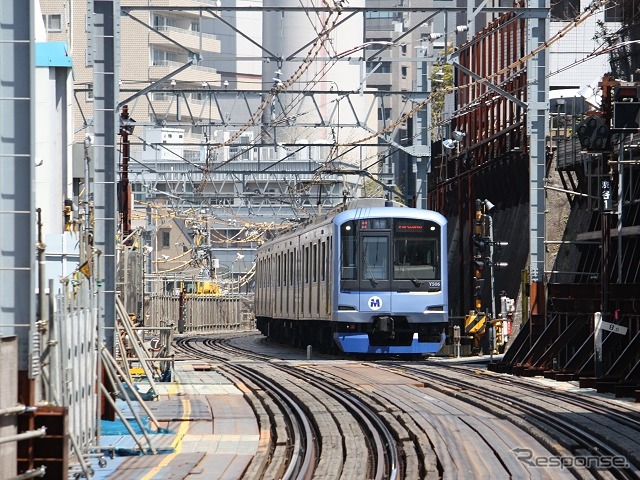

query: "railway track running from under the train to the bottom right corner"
(386, 363), (640, 479)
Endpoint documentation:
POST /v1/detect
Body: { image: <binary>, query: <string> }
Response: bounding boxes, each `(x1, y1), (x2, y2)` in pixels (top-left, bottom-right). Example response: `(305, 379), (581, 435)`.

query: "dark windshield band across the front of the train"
(340, 218), (441, 291)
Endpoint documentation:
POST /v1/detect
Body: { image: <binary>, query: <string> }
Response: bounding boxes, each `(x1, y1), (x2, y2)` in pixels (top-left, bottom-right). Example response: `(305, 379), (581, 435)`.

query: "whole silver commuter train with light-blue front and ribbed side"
(255, 199), (448, 355)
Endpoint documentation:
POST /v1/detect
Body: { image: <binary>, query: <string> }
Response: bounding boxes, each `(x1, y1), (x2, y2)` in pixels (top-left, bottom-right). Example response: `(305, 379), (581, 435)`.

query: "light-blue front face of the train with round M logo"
(333, 208), (448, 355)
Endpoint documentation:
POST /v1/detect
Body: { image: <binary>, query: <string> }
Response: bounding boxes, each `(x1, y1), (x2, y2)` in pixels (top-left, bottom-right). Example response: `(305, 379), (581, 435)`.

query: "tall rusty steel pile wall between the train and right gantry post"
(429, 13), (529, 317)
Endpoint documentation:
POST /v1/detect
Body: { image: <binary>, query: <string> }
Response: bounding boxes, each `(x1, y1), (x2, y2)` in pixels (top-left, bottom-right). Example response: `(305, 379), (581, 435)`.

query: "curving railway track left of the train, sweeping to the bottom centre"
(176, 338), (399, 480)
